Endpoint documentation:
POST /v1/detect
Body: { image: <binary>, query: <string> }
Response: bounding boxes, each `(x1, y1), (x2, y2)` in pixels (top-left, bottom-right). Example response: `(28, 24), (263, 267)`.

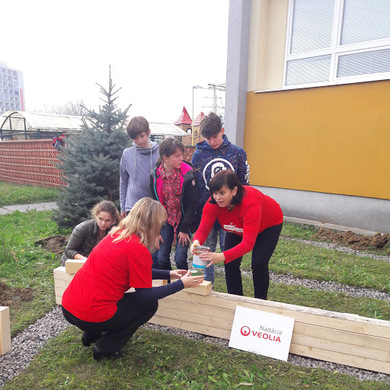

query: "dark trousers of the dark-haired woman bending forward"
(225, 224), (283, 299)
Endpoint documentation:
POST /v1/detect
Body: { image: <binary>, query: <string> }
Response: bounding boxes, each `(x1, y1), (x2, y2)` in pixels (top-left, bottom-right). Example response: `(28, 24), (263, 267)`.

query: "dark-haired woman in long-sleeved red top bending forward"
(191, 170), (283, 299)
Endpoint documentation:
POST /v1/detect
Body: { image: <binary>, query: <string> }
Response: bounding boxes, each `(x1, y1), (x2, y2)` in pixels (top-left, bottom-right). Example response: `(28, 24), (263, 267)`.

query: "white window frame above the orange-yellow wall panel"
(283, 0), (390, 89)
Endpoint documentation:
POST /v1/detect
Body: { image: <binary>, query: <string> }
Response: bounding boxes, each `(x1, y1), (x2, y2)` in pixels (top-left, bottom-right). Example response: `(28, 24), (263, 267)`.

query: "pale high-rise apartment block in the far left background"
(0, 62), (26, 114)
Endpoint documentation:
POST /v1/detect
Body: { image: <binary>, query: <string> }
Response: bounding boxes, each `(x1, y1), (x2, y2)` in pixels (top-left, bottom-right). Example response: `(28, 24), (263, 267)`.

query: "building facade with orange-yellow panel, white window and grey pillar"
(225, 0), (390, 233)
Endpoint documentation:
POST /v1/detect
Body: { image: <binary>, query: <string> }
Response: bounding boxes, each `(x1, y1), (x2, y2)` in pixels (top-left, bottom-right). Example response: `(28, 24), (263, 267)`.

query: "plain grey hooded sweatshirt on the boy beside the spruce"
(119, 142), (160, 212)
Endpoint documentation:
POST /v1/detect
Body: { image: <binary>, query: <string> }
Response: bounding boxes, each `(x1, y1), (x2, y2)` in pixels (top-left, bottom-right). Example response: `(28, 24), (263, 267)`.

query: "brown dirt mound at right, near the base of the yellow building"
(314, 228), (390, 254)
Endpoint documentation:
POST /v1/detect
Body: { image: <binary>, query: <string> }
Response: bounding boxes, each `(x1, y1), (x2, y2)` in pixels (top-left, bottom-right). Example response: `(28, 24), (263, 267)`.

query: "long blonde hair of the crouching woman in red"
(110, 198), (167, 251)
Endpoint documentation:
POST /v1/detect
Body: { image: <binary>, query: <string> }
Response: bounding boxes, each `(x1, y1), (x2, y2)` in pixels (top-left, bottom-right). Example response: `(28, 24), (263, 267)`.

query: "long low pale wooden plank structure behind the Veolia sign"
(53, 260), (390, 374)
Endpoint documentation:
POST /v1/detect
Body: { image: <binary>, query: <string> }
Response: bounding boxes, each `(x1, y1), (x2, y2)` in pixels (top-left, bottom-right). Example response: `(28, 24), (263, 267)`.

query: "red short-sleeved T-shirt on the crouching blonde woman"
(62, 234), (152, 322)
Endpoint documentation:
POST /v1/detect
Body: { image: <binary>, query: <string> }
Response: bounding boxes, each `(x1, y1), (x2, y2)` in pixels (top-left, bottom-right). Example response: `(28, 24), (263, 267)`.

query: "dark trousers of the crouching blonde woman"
(62, 293), (158, 354)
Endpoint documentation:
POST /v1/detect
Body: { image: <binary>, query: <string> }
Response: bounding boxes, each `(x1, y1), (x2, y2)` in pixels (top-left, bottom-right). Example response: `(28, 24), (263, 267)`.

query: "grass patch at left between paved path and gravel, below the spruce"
(0, 211), (64, 335)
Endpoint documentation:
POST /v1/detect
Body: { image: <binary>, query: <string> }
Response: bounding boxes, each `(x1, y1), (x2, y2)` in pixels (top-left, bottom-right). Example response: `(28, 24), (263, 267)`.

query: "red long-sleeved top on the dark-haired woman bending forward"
(194, 186), (283, 263)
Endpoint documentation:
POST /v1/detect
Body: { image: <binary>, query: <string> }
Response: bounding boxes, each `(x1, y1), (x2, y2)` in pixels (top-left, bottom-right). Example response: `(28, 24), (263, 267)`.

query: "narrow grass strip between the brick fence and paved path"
(0, 181), (59, 207)
